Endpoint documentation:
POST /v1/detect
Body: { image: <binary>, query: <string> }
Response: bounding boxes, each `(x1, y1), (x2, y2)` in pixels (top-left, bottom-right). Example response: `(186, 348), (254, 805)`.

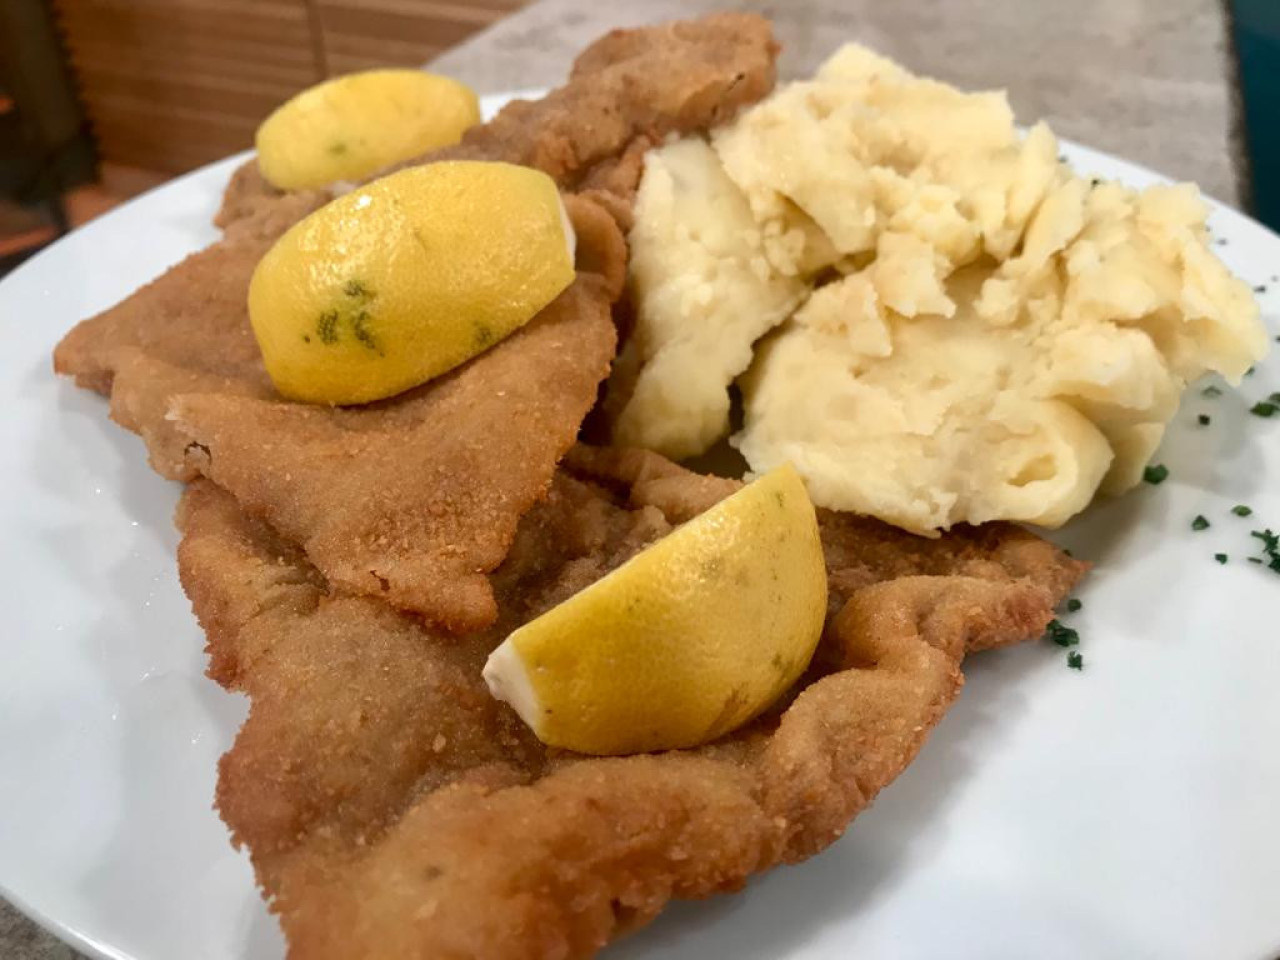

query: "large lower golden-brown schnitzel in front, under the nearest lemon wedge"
(179, 448), (1083, 960)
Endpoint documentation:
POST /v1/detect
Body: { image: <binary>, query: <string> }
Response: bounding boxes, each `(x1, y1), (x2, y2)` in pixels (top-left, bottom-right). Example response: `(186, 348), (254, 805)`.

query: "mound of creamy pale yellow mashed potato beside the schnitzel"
(618, 46), (1267, 532)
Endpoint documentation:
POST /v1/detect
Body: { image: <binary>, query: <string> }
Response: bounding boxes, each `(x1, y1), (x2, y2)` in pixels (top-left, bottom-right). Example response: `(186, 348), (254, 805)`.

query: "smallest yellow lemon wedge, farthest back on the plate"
(255, 70), (480, 189)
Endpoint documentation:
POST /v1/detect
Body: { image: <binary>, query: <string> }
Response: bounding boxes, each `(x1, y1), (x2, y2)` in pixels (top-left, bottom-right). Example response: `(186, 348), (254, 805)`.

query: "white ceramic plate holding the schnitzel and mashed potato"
(0, 92), (1280, 960)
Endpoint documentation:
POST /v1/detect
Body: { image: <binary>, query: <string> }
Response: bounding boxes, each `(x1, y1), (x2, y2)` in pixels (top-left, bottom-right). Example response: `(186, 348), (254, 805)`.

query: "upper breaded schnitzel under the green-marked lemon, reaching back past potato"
(54, 15), (776, 631)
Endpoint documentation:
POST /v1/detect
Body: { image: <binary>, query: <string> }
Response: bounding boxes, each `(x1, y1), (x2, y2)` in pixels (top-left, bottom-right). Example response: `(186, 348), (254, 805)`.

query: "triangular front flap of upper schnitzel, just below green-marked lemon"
(170, 274), (614, 630)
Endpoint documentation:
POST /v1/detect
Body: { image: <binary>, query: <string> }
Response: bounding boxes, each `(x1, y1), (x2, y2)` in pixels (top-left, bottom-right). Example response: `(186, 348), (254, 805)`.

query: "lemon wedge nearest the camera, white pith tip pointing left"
(484, 465), (827, 755)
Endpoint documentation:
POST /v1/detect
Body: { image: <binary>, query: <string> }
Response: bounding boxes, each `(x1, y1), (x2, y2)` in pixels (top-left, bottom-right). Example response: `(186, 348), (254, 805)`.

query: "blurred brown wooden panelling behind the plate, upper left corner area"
(54, 0), (525, 173)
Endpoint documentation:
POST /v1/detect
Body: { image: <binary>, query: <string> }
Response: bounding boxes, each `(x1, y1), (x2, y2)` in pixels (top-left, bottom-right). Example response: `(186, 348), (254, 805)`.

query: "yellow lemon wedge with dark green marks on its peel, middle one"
(248, 161), (575, 404)
